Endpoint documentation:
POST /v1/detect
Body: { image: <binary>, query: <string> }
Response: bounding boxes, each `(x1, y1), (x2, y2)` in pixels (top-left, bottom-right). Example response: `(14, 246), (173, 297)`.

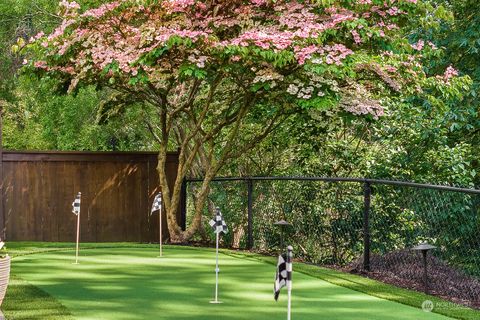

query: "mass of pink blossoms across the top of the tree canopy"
(32, 0), (415, 97)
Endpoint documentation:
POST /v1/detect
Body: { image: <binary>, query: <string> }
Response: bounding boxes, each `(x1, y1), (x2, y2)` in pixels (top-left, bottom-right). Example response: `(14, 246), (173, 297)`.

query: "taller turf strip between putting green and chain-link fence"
(222, 250), (480, 320)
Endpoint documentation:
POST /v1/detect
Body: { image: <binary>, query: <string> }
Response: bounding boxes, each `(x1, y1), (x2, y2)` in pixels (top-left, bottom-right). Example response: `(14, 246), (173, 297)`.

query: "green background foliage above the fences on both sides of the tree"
(0, 0), (480, 186)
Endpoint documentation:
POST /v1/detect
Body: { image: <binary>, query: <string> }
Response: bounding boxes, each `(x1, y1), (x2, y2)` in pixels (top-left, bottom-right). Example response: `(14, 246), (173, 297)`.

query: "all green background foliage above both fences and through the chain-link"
(0, 0), (480, 310)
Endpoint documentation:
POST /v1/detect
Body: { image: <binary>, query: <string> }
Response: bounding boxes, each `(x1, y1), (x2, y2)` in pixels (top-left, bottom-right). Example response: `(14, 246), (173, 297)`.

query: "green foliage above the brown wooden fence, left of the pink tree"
(0, 0), (155, 151)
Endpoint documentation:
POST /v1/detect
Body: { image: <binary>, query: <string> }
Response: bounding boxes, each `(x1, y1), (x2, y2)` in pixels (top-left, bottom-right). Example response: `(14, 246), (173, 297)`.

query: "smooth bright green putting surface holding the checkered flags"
(12, 247), (450, 320)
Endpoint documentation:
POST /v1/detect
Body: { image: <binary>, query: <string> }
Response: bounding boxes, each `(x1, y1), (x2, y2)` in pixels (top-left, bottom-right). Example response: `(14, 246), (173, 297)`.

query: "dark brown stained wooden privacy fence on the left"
(0, 151), (180, 242)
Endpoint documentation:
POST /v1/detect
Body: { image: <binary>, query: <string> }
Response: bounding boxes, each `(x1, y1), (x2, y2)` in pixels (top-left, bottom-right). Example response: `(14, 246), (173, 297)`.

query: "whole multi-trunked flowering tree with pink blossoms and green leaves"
(24, 0), (466, 241)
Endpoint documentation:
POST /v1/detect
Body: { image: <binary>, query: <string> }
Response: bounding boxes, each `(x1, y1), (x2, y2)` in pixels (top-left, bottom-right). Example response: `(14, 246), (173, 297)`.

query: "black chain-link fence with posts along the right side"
(184, 177), (480, 307)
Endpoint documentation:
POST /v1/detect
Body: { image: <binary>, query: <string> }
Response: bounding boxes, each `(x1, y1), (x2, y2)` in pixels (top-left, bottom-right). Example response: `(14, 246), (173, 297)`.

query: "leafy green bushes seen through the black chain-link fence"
(187, 180), (480, 277)
